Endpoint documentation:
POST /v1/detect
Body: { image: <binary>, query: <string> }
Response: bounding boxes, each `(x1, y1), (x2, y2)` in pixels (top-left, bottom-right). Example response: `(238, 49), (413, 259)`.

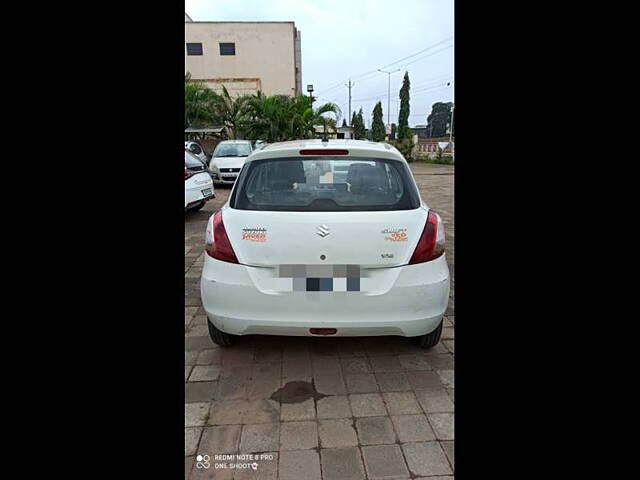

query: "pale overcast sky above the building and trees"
(185, 0), (454, 127)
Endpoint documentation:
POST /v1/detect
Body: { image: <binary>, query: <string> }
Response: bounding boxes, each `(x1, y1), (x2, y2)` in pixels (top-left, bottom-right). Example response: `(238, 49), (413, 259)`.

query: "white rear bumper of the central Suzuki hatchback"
(200, 255), (449, 337)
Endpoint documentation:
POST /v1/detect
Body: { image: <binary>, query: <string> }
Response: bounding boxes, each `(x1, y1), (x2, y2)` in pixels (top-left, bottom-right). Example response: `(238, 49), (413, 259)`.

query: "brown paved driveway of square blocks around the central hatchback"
(184, 164), (455, 480)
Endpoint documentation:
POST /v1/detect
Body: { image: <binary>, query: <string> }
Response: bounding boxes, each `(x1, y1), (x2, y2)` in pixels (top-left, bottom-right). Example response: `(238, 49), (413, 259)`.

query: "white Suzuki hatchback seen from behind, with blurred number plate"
(200, 140), (449, 348)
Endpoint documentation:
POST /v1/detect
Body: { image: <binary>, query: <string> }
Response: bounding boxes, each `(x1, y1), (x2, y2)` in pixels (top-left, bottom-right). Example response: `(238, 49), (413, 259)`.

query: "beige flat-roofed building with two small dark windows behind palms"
(184, 13), (302, 96)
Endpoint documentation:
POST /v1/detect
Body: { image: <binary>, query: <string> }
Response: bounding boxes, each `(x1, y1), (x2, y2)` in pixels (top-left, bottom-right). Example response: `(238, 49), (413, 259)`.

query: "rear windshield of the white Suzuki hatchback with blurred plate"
(230, 157), (420, 212)
